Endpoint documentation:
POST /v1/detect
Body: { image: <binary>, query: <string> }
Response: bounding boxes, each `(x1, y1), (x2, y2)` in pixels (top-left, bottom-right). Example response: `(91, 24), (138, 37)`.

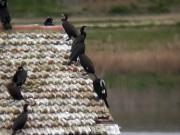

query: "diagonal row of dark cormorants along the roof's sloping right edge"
(61, 13), (109, 108)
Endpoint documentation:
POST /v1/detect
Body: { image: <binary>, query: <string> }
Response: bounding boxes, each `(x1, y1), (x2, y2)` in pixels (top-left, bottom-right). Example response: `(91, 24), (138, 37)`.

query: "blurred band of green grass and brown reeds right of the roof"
(87, 26), (180, 91)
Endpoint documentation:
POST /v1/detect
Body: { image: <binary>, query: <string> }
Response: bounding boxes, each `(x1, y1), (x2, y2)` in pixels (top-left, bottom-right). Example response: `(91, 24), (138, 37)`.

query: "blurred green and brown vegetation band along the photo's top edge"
(9, 0), (180, 18)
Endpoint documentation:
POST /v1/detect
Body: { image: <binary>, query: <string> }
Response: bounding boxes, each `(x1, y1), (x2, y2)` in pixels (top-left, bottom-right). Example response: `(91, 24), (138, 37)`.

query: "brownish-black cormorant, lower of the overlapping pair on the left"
(6, 82), (24, 100)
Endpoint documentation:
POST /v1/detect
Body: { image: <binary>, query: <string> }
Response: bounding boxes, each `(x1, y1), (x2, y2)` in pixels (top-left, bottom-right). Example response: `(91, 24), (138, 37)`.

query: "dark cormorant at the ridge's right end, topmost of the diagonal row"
(61, 13), (78, 40)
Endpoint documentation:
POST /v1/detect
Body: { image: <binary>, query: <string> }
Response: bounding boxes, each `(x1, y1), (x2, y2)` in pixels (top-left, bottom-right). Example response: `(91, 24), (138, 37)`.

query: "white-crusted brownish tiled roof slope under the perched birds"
(0, 32), (119, 135)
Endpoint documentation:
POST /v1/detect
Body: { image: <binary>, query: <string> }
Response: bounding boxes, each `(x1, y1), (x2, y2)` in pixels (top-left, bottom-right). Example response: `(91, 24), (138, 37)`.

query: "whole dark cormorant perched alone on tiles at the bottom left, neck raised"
(12, 104), (29, 135)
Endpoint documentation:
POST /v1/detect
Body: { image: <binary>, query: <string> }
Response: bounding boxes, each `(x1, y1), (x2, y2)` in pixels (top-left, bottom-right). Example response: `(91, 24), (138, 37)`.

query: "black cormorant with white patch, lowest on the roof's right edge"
(93, 78), (109, 108)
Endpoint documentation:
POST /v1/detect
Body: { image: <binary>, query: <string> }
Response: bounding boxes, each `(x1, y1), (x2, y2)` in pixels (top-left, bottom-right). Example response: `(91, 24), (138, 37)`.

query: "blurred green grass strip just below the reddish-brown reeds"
(105, 73), (180, 91)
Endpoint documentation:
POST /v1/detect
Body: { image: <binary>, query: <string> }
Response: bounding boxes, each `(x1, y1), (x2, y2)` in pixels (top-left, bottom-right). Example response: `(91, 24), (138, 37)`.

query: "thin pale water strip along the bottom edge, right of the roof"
(122, 132), (180, 135)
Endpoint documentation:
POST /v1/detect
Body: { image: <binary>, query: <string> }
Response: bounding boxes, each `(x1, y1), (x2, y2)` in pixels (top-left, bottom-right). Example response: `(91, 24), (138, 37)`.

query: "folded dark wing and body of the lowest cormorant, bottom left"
(12, 112), (28, 131)
